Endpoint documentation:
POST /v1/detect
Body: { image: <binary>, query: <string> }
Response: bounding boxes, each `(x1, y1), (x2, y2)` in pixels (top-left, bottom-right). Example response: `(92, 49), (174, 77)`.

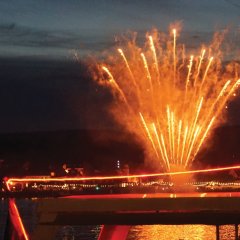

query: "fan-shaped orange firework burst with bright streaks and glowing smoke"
(96, 28), (240, 172)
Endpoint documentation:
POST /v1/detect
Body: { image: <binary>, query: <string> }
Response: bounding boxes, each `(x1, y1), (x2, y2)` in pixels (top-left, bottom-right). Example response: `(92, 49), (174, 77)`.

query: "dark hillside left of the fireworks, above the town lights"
(0, 130), (144, 175)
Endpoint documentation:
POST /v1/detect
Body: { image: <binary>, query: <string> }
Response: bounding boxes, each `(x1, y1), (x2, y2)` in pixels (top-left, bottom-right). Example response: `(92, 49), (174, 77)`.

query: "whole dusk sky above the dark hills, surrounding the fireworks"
(0, 0), (240, 132)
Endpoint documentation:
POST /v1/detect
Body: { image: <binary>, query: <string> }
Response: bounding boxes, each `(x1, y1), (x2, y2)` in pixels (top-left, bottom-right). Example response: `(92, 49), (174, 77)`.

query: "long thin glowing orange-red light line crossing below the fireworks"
(5, 165), (240, 189)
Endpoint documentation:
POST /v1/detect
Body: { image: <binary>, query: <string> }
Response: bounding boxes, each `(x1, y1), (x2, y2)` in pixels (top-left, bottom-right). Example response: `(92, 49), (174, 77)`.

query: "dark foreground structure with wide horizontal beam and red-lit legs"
(5, 192), (240, 240)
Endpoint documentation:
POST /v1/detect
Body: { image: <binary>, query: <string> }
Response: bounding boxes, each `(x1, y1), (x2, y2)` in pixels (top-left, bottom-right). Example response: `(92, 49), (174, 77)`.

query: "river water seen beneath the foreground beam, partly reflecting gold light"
(0, 199), (238, 240)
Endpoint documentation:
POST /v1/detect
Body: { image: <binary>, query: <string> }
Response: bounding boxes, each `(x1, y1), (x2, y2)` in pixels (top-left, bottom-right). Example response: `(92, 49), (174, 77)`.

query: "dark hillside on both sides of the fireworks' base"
(0, 126), (240, 175)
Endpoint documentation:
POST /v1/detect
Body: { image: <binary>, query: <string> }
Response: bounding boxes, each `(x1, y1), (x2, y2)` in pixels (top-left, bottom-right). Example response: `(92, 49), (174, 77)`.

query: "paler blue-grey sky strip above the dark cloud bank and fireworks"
(0, 0), (240, 58)
